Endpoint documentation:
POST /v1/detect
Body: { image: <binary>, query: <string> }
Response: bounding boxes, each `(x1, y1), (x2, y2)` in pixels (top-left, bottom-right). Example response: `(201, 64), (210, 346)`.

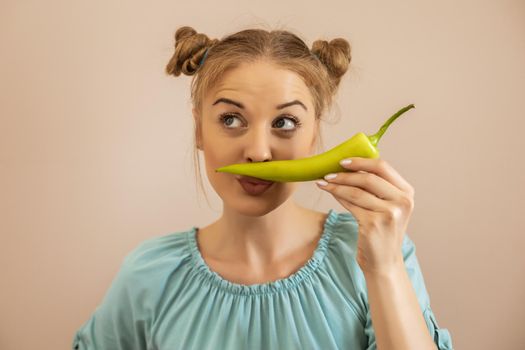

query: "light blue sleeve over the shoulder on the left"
(75, 229), (193, 349)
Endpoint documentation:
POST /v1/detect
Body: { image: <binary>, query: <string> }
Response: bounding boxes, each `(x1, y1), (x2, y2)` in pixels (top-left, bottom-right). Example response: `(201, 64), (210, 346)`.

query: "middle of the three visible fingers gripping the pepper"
(324, 172), (402, 200)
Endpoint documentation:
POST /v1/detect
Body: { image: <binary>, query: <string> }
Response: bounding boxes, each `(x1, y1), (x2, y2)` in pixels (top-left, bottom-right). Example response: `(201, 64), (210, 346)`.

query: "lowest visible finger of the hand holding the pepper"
(317, 182), (387, 212)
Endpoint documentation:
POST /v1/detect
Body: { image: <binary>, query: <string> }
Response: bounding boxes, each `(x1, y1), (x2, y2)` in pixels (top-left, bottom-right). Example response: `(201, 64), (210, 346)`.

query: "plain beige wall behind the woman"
(0, 0), (525, 350)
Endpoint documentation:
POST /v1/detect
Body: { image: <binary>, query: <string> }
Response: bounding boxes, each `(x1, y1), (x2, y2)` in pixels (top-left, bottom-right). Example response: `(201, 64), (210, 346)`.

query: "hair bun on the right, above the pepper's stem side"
(311, 38), (352, 84)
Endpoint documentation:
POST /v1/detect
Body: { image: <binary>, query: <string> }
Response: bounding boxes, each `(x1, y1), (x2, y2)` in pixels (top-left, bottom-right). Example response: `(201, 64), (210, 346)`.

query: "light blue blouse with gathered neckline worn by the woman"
(72, 209), (452, 350)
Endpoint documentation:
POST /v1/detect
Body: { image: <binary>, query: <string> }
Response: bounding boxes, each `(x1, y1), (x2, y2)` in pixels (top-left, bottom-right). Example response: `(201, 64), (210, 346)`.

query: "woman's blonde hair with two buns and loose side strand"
(166, 26), (351, 203)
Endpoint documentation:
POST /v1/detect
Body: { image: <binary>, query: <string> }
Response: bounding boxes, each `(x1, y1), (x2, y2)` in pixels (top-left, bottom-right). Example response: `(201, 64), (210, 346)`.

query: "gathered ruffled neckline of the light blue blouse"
(187, 209), (339, 295)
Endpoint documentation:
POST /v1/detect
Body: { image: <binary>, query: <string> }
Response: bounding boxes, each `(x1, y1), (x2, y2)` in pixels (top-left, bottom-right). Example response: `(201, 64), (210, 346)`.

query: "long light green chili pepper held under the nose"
(215, 104), (414, 182)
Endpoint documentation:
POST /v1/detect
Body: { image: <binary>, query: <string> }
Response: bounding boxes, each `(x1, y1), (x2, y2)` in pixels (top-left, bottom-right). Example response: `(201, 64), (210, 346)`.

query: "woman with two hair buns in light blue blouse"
(73, 27), (452, 350)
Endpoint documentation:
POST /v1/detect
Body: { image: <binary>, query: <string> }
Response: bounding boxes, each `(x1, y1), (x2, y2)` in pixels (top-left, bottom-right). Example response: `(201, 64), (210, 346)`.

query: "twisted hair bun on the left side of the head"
(166, 26), (219, 77)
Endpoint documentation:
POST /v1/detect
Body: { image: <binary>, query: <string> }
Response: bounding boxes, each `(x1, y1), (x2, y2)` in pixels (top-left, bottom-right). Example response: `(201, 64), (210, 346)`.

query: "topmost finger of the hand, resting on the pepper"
(341, 157), (413, 193)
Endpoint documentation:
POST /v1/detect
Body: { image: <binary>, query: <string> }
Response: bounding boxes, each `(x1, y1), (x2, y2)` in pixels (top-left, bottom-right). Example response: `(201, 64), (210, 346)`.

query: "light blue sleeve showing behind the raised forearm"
(365, 234), (453, 350)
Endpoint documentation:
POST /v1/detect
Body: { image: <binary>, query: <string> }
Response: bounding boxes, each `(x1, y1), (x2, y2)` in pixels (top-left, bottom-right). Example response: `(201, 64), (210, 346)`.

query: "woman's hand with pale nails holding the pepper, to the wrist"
(318, 157), (414, 275)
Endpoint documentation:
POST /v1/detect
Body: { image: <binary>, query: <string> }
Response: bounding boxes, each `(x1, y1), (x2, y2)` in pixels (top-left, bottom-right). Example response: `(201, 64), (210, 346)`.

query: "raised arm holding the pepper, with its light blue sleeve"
(318, 157), (452, 350)
